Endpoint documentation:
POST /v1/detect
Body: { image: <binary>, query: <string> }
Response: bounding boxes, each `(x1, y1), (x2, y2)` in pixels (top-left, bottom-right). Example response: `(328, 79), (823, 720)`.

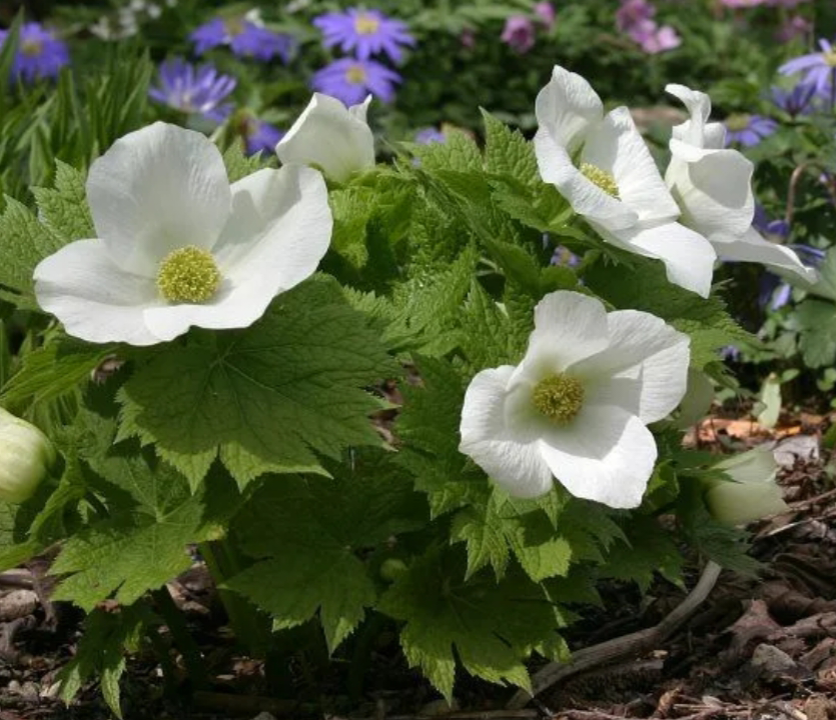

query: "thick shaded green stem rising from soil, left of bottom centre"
(198, 540), (270, 657)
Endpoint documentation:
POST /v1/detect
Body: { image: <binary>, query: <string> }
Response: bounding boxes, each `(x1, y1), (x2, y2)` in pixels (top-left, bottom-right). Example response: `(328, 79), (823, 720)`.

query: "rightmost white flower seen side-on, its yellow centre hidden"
(665, 85), (817, 282)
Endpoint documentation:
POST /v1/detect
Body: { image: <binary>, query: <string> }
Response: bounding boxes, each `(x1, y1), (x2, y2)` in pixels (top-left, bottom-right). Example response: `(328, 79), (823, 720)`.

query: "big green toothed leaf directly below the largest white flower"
(119, 278), (398, 487)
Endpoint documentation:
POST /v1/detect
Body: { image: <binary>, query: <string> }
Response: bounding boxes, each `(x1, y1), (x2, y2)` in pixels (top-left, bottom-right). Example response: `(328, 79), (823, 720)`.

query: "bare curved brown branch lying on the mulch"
(505, 561), (722, 710)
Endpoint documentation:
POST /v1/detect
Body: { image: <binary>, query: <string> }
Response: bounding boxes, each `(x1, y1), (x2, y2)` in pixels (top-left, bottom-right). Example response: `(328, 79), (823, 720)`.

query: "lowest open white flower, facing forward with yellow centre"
(459, 291), (690, 508)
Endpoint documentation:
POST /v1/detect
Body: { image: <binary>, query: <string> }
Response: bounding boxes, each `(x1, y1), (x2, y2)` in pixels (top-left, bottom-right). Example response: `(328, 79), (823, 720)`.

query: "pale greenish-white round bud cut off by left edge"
(0, 408), (56, 503)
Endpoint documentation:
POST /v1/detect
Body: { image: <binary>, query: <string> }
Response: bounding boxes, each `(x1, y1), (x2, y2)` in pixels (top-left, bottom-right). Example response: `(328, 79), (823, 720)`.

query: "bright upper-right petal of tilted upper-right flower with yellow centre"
(581, 107), (679, 225)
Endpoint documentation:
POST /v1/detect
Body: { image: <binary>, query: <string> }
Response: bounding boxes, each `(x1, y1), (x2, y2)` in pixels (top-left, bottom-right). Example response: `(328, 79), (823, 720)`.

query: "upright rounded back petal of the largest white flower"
(87, 122), (231, 277)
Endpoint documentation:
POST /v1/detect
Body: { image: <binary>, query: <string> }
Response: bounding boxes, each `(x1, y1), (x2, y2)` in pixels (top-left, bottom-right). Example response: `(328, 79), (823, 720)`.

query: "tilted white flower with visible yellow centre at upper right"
(534, 66), (716, 297)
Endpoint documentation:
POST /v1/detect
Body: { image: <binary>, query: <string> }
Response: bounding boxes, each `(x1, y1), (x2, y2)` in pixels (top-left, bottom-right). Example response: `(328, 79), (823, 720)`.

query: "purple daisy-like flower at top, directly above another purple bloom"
(313, 8), (415, 62)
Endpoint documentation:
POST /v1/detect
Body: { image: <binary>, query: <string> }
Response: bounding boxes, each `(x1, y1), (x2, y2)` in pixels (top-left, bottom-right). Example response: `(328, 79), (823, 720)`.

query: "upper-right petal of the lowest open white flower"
(571, 310), (691, 423)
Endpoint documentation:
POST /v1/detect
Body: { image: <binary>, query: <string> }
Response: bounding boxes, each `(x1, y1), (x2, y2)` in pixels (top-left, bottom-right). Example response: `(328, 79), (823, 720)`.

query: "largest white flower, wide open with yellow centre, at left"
(34, 123), (332, 345)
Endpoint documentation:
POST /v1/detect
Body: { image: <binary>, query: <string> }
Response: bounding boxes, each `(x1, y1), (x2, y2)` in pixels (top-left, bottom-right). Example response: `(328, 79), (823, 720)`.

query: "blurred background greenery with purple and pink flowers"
(0, 0), (836, 405)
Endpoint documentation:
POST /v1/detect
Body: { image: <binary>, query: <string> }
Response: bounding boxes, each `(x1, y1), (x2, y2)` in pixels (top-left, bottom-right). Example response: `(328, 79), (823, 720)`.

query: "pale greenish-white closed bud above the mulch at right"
(705, 448), (789, 525)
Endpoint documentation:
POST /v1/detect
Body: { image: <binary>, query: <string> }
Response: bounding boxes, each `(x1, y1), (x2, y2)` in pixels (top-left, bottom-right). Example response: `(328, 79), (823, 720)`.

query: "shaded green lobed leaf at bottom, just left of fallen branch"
(378, 549), (562, 700)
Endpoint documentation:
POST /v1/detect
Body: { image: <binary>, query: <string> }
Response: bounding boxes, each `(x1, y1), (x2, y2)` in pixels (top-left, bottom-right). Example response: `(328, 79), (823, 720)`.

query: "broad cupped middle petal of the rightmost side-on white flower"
(665, 140), (755, 236)
